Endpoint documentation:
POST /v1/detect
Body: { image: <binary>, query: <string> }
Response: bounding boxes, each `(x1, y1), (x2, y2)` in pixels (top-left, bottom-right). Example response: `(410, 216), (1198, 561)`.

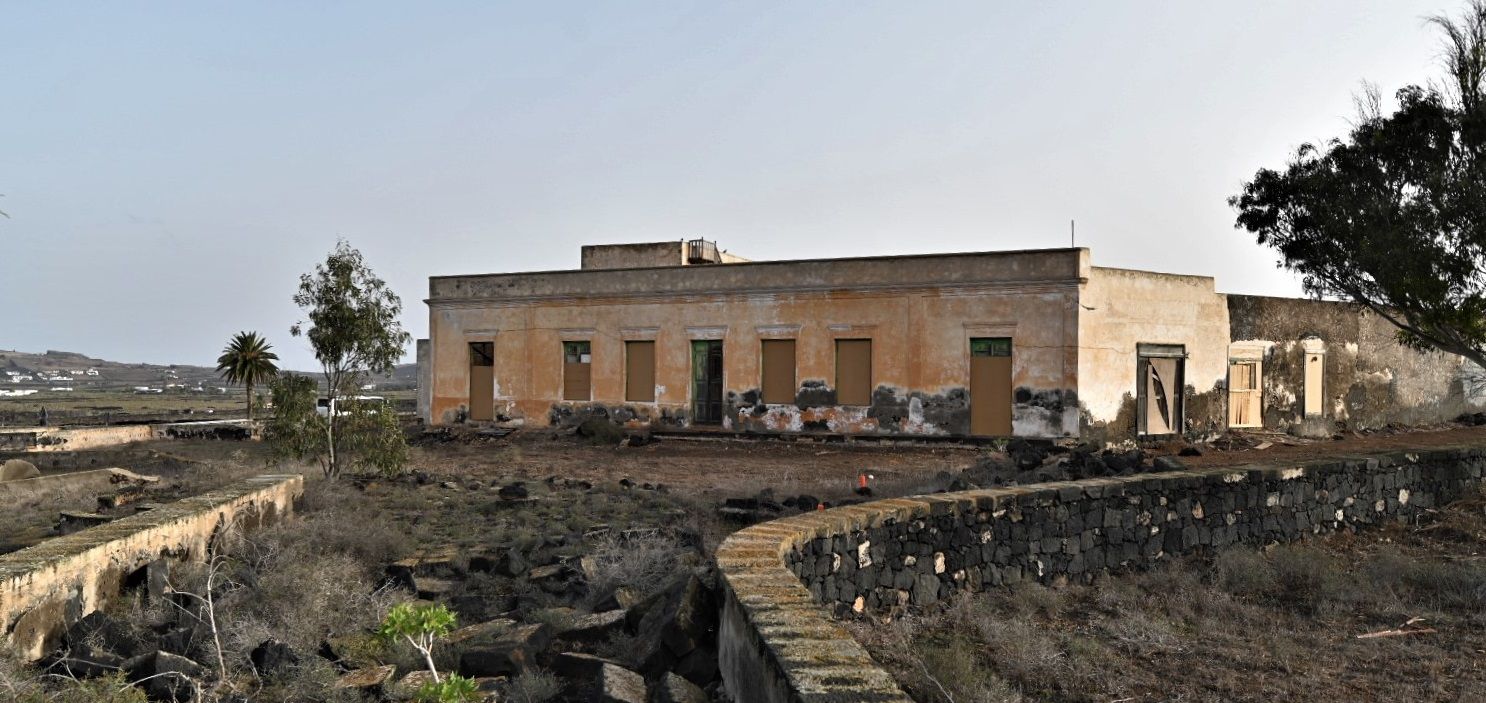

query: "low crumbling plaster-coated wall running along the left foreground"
(0, 474), (305, 660)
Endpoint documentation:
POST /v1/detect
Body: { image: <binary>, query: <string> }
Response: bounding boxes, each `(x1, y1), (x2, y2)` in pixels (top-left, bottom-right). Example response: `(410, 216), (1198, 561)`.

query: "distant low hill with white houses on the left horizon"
(0, 349), (418, 391)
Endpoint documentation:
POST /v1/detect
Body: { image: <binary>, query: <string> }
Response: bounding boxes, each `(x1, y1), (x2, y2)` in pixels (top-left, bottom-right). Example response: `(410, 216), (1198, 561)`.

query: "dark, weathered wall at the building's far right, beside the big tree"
(1227, 296), (1486, 430)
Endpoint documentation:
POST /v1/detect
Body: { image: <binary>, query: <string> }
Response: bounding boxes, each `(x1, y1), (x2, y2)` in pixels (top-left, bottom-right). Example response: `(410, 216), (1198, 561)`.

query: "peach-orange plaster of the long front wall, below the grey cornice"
(428, 251), (1086, 435)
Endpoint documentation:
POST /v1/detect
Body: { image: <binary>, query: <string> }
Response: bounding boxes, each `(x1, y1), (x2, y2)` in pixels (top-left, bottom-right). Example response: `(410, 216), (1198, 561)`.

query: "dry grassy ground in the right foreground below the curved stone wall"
(851, 493), (1486, 703)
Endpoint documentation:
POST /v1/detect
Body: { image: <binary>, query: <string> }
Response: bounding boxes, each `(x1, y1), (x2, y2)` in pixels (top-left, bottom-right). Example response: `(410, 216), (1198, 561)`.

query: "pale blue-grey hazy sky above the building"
(0, 0), (1458, 369)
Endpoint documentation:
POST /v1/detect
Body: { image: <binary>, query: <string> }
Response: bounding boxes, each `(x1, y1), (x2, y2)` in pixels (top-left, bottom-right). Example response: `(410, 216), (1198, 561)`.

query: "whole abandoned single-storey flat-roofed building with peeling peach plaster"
(419, 241), (1486, 440)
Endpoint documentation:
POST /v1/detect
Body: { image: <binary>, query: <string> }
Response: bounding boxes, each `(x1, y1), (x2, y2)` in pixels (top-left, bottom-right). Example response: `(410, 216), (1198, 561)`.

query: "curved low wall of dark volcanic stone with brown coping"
(718, 447), (1486, 703)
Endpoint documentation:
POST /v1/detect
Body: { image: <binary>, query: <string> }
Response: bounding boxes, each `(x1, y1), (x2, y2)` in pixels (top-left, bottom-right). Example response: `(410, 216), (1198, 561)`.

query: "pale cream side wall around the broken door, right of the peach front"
(1079, 266), (1229, 441)
